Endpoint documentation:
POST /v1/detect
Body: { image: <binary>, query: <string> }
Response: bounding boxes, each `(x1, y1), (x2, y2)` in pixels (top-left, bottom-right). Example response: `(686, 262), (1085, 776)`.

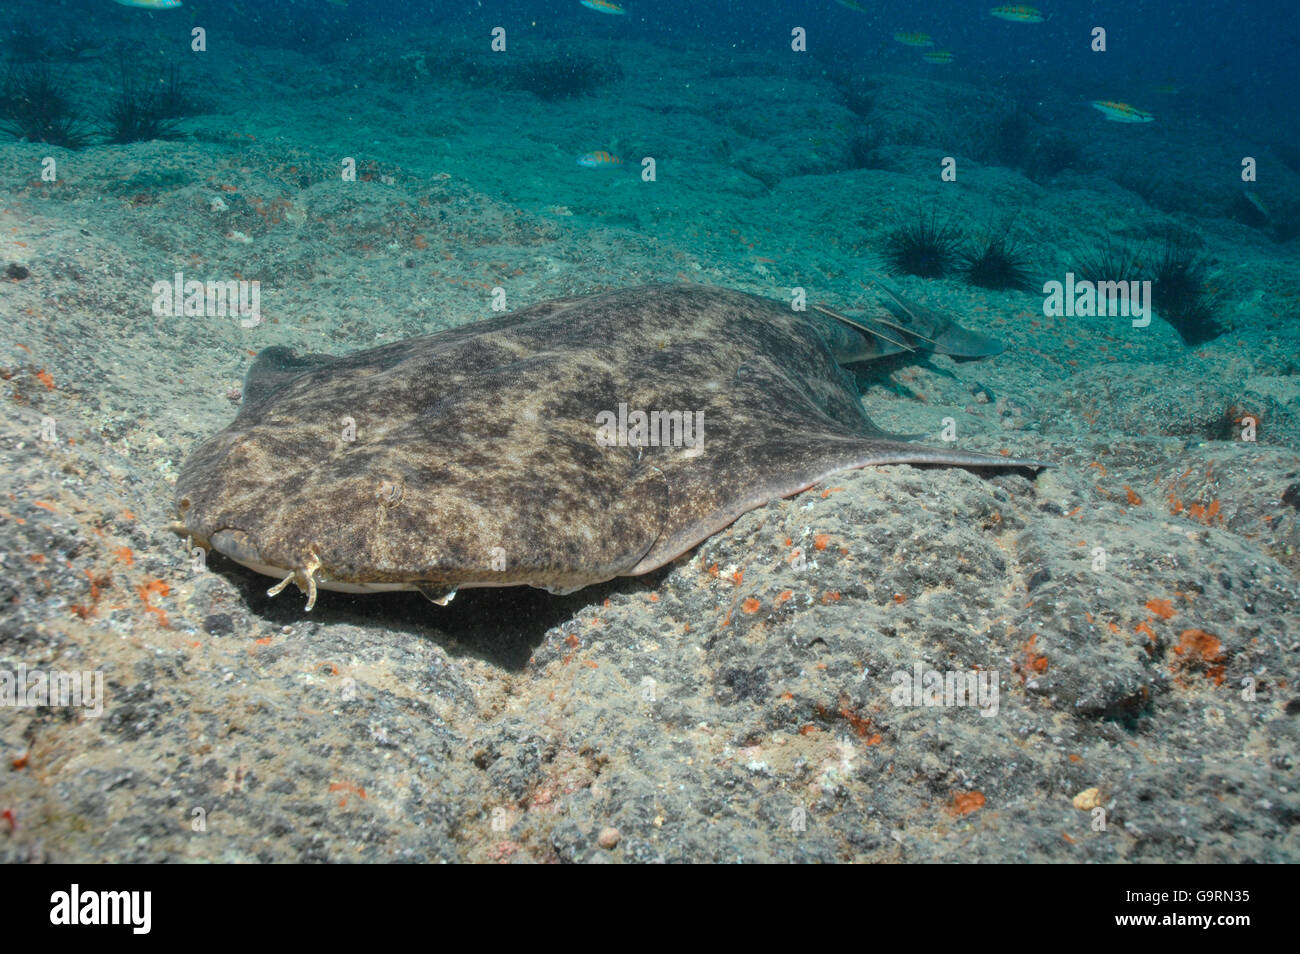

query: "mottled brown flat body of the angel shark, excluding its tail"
(176, 286), (1036, 590)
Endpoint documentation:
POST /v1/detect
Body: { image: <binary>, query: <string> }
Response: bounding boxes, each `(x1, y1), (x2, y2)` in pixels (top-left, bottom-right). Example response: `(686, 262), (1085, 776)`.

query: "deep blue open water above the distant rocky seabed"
(197, 0), (1300, 115)
